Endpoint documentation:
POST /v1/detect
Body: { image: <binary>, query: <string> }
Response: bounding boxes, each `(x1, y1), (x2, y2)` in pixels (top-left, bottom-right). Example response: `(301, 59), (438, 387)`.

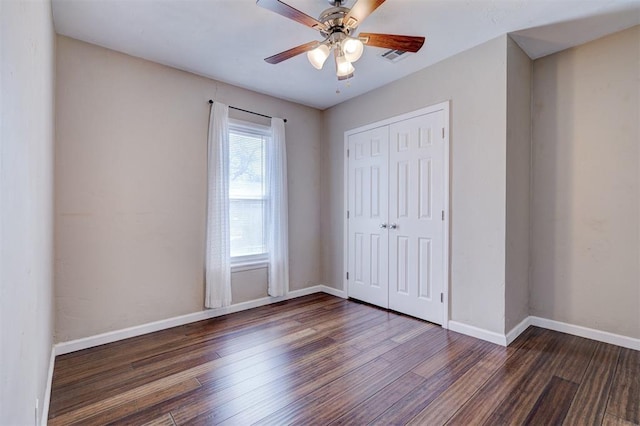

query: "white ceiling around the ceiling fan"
(53, 0), (640, 109)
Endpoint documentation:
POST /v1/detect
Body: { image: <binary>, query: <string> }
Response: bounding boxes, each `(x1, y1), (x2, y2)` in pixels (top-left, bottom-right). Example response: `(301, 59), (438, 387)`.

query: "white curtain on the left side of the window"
(204, 102), (231, 308)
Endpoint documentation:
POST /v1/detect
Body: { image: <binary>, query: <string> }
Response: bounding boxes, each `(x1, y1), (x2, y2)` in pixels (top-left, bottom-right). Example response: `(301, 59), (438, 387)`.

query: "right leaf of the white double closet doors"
(389, 110), (446, 324)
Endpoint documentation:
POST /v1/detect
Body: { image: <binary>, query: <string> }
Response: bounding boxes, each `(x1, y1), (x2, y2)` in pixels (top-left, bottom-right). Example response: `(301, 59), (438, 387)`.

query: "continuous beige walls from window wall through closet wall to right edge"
(55, 21), (640, 352)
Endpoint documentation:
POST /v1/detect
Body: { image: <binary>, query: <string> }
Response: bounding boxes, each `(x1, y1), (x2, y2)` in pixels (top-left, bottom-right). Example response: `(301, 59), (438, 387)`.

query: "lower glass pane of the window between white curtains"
(229, 199), (266, 257)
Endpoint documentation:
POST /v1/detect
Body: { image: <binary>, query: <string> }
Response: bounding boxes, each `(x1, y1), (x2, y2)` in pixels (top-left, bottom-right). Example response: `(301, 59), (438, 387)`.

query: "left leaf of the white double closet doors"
(347, 126), (389, 308)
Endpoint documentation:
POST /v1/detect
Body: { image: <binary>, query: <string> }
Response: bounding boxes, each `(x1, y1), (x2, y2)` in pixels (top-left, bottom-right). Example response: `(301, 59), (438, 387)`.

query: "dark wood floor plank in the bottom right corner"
(607, 348), (640, 424)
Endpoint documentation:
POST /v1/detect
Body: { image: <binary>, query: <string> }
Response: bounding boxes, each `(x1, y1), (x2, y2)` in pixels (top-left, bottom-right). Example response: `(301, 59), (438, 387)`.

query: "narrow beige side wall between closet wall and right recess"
(505, 38), (532, 333)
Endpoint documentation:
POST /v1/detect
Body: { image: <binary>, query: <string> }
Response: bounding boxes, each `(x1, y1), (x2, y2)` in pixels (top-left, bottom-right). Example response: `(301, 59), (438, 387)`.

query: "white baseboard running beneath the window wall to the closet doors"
(54, 285), (346, 355)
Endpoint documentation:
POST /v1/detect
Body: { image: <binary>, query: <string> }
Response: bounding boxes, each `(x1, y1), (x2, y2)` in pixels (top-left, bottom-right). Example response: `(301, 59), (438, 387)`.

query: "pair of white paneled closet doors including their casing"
(345, 102), (449, 327)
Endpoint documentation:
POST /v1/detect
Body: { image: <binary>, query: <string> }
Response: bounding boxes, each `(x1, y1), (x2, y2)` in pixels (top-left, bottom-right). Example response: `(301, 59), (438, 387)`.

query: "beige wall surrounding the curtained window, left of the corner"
(55, 37), (322, 341)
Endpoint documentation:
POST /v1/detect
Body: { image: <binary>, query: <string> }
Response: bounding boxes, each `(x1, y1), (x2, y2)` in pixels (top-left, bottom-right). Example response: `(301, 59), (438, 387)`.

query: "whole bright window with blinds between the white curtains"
(229, 120), (271, 264)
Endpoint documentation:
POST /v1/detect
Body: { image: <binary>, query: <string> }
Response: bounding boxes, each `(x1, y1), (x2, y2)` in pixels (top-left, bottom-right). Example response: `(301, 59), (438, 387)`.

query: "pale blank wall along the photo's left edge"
(0, 1), (55, 425)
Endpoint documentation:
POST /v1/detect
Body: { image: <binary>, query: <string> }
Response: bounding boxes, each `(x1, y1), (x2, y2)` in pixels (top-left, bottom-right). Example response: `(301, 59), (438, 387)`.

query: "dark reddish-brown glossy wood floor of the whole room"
(49, 294), (640, 425)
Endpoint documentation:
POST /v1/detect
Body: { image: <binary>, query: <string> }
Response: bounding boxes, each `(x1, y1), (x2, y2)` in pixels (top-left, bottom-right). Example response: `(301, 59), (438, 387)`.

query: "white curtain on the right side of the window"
(266, 118), (289, 297)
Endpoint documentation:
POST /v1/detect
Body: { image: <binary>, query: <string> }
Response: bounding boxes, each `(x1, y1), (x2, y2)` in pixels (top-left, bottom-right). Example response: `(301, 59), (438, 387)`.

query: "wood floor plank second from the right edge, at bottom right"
(563, 343), (620, 425)
